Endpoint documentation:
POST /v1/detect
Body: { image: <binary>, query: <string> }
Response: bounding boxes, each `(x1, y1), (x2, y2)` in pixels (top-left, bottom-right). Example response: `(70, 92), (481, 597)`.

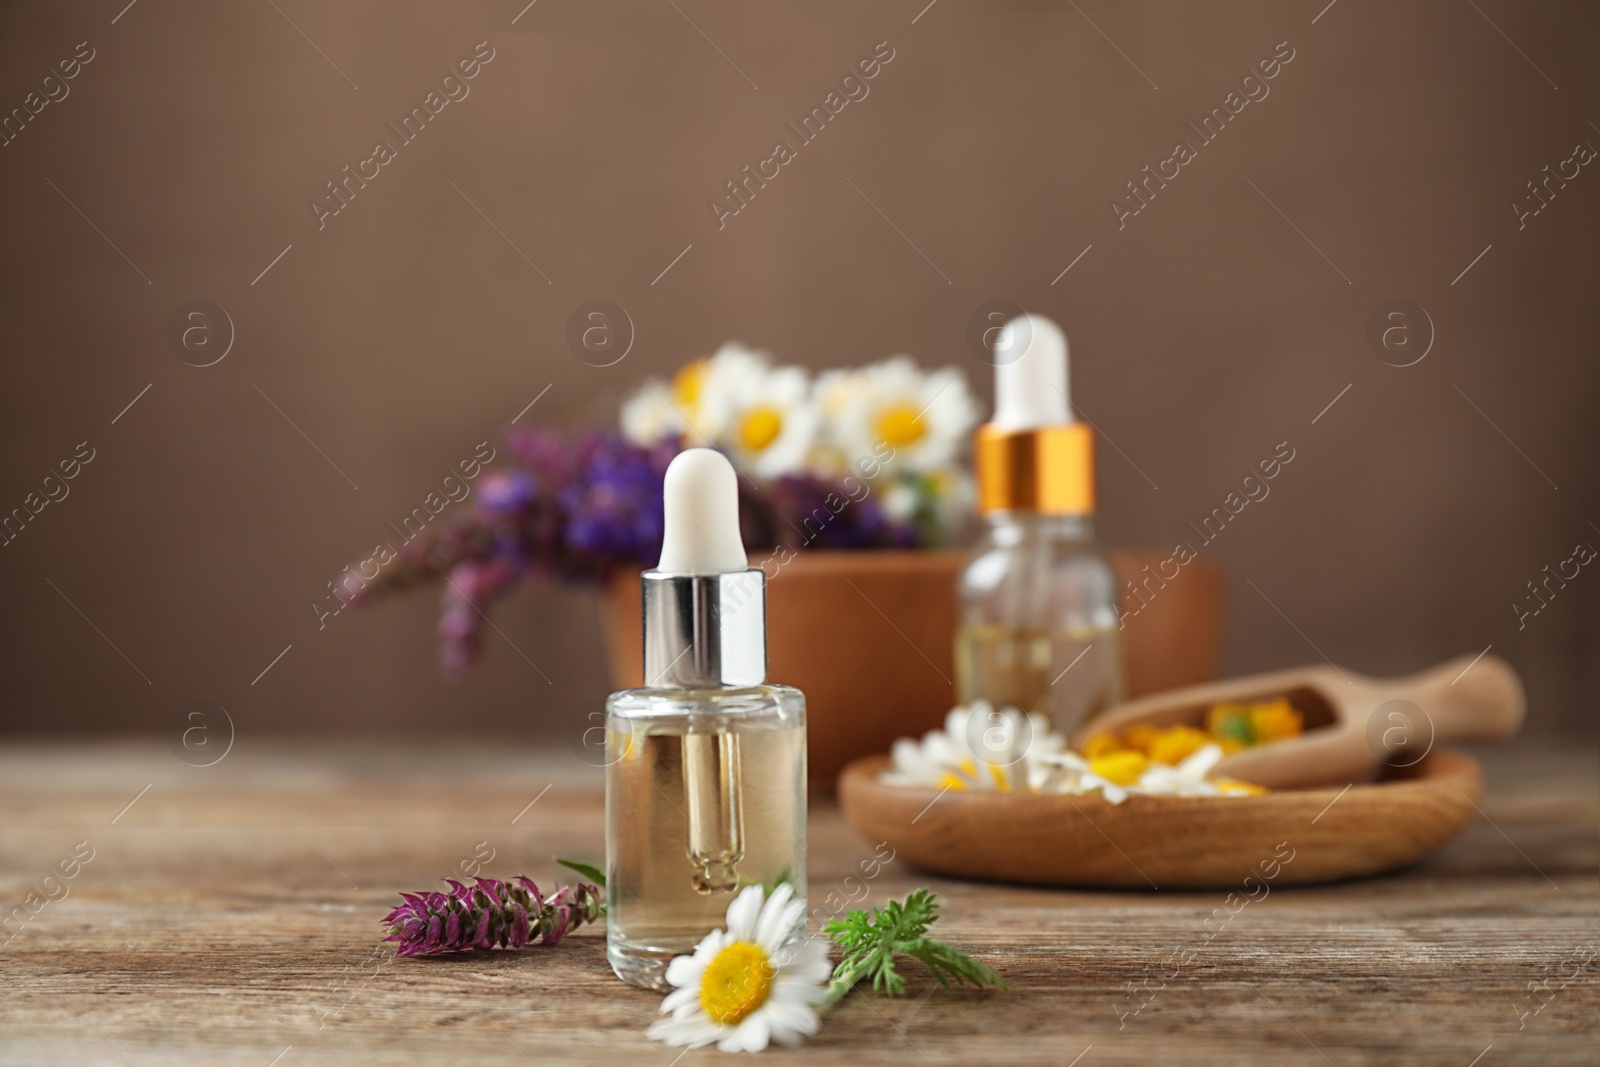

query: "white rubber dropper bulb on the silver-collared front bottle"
(656, 448), (750, 574)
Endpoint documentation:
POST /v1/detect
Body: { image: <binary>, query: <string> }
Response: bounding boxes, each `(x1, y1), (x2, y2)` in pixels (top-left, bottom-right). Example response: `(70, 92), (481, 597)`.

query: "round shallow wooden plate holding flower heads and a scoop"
(838, 749), (1483, 889)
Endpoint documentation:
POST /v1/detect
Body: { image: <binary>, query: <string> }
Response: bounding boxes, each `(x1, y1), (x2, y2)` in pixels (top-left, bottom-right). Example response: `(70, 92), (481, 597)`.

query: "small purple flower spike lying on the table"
(384, 875), (605, 957)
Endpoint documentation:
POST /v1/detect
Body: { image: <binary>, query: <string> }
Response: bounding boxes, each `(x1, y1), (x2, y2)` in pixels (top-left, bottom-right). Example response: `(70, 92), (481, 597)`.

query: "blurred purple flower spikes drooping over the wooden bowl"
(355, 427), (930, 678)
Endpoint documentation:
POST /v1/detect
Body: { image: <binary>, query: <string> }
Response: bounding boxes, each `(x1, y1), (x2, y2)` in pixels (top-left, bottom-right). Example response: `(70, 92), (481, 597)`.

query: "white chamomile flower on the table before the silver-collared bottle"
(646, 883), (832, 1053)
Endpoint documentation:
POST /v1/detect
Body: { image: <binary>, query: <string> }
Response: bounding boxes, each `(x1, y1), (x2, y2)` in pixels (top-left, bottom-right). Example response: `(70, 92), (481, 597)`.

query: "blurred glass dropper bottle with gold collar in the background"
(955, 315), (1123, 733)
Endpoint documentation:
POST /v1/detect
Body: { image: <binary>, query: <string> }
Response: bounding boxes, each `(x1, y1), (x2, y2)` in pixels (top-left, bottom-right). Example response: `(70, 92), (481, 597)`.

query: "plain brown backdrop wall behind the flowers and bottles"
(0, 0), (1600, 736)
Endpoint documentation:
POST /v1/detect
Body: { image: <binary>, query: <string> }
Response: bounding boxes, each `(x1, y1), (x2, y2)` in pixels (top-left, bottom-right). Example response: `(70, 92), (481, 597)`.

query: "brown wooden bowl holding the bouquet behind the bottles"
(606, 549), (1222, 790)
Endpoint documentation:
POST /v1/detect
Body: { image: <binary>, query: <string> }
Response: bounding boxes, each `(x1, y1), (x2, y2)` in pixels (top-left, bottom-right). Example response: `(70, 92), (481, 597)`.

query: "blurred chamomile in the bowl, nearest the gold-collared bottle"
(816, 355), (978, 472)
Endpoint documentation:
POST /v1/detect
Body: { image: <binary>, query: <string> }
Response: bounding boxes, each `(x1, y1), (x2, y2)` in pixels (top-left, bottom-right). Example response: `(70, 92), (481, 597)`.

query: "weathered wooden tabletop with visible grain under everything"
(0, 739), (1600, 1067)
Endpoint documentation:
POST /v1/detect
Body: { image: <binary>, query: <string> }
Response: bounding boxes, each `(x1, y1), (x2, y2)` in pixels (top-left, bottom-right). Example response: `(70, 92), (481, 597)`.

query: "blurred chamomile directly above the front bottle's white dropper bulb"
(704, 346), (819, 478)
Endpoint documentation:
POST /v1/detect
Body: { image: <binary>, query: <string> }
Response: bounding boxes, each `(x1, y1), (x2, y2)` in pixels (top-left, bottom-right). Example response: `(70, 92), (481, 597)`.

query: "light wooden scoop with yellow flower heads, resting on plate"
(1072, 656), (1528, 789)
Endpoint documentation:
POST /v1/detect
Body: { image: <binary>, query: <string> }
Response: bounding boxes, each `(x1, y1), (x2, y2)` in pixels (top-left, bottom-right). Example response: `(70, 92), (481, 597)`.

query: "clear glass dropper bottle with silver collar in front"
(605, 448), (806, 989)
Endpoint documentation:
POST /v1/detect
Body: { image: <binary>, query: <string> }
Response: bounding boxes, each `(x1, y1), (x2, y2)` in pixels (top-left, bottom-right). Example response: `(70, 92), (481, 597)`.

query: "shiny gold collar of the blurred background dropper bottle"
(973, 422), (1094, 515)
